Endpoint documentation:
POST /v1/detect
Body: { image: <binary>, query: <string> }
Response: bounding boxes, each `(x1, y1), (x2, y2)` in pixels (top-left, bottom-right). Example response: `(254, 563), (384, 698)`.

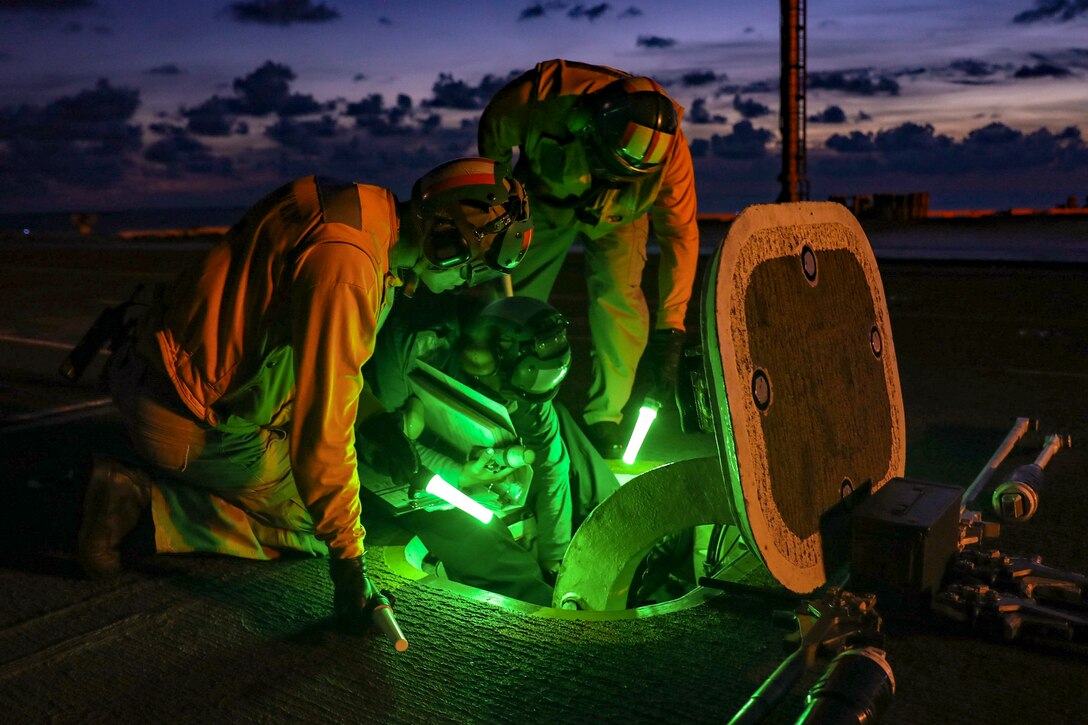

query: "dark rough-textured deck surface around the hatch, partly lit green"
(0, 232), (1088, 723)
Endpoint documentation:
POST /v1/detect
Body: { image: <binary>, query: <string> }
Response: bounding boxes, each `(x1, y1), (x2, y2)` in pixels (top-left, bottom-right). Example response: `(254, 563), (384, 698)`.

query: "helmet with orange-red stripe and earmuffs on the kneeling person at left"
(411, 158), (533, 285)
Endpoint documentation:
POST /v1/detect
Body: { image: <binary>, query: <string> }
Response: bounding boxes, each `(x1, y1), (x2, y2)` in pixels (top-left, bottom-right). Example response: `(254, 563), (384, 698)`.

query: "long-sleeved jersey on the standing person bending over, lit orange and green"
(479, 60), (698, 330)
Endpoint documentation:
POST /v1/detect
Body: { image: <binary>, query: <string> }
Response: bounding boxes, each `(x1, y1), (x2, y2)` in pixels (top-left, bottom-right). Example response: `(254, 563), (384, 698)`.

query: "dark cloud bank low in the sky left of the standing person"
(0, 62), (511, 208)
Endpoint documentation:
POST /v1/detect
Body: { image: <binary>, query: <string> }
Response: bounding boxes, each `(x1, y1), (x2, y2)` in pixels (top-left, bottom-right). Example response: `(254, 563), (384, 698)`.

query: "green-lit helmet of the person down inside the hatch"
(461, 297), (570, 403)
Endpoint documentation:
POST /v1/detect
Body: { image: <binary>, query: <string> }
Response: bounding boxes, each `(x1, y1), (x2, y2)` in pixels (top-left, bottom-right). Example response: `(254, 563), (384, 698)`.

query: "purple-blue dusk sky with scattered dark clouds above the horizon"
(0, 0), (1088, 212)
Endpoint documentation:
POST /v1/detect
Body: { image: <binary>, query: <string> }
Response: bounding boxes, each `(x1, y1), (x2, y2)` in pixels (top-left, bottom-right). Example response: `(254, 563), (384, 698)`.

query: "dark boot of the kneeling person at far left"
(78, 455), (151, 579)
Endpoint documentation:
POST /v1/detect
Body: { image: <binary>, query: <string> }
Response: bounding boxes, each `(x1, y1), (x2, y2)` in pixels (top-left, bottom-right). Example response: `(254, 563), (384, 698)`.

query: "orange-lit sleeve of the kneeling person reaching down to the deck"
(290, 243), (384, 558)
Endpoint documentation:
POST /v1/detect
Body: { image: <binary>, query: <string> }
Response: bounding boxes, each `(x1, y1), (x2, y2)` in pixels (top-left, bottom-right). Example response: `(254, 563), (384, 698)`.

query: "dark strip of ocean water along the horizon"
(0, 208), (1088, 263)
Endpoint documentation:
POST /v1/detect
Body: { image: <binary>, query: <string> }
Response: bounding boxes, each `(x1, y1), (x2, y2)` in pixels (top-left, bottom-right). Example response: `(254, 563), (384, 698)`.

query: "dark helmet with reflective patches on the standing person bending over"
(574, 77), (678, 179)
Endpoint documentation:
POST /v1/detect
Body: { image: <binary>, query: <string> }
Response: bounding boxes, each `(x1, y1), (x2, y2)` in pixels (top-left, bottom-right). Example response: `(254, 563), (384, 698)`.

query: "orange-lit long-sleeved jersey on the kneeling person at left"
(138, 176), (399, 557)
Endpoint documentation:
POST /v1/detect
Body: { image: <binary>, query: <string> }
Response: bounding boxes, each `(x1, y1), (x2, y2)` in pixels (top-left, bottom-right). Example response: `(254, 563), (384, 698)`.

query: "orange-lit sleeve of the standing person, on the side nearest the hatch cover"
(650, 131), (698, 330)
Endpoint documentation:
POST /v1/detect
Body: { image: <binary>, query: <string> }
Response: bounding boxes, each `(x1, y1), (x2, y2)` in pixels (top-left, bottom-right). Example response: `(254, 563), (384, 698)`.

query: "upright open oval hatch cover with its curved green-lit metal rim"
(555, 202), (905, 609)
